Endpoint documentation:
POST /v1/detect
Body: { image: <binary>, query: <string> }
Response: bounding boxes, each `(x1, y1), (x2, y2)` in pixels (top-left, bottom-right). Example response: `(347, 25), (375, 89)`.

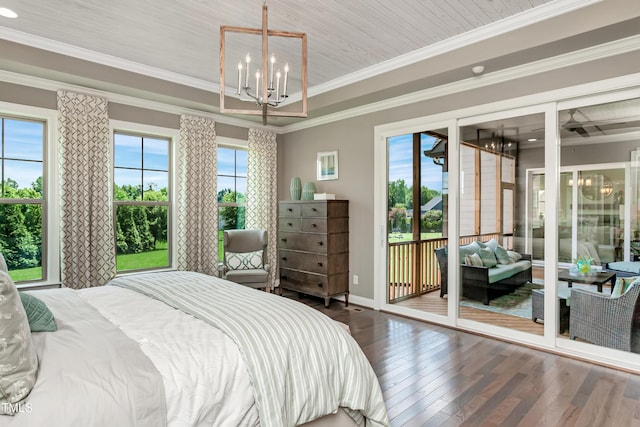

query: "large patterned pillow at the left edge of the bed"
(0, 271), (38, 414)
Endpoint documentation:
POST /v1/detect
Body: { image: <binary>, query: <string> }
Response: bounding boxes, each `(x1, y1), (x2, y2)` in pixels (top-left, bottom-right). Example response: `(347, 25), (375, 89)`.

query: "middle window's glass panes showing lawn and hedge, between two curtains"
(113, 131), (171, 271)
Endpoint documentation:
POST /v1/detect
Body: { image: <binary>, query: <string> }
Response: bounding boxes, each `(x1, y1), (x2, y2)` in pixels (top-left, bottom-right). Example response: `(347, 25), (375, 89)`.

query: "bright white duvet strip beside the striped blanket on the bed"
(78, 286), (259, 426)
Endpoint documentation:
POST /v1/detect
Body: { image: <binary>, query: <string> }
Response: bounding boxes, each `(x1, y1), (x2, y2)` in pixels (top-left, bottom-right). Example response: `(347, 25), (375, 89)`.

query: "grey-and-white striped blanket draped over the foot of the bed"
(110, 271), (389, 427)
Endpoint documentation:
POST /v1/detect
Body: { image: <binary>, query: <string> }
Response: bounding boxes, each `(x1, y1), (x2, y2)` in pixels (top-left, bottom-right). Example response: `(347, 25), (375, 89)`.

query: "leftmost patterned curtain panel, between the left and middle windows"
(58, 91), (116, 289)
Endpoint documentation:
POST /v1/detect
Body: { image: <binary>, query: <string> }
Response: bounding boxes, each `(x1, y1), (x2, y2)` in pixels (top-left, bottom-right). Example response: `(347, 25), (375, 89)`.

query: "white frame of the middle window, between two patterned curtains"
(109, 120), (179, 276)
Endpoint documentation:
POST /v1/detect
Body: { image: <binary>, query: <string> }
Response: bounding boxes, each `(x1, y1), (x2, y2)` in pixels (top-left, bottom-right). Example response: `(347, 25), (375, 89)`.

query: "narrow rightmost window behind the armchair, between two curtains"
(218, 147), (247, 259)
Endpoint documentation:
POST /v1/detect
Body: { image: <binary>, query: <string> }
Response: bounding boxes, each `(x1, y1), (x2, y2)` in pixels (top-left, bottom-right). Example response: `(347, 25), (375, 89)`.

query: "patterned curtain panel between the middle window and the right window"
(176, 115), (218, 276)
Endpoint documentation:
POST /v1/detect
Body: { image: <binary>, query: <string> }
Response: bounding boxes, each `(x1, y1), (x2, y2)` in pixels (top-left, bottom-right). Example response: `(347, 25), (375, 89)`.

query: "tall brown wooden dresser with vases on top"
(278, 200), (349, 307)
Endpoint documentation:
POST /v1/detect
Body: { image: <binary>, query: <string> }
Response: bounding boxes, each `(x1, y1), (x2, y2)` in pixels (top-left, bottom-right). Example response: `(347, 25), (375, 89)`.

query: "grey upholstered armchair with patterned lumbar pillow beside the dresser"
(222, 230), (271, 289)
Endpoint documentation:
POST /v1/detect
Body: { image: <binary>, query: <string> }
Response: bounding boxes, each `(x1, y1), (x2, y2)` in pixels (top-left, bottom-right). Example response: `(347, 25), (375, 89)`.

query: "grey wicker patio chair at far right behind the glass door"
(569, 284), (640, 351)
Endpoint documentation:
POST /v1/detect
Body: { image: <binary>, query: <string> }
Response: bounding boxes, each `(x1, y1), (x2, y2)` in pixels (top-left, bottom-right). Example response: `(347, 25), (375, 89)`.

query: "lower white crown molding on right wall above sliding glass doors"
(282, 35), (640, 133)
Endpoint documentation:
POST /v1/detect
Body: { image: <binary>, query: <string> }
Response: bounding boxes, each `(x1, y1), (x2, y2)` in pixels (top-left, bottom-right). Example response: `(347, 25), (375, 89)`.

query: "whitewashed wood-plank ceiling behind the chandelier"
(0, 0), (556, 93)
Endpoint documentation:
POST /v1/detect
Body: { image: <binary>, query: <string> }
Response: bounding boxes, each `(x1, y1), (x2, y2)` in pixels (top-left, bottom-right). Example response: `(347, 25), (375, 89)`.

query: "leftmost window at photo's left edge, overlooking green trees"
(0, 116), (46, 282)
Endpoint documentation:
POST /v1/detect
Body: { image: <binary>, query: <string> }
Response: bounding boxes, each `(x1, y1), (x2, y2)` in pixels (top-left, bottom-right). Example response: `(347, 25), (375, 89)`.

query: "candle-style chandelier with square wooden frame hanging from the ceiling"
(220, 2), (307, 125)
